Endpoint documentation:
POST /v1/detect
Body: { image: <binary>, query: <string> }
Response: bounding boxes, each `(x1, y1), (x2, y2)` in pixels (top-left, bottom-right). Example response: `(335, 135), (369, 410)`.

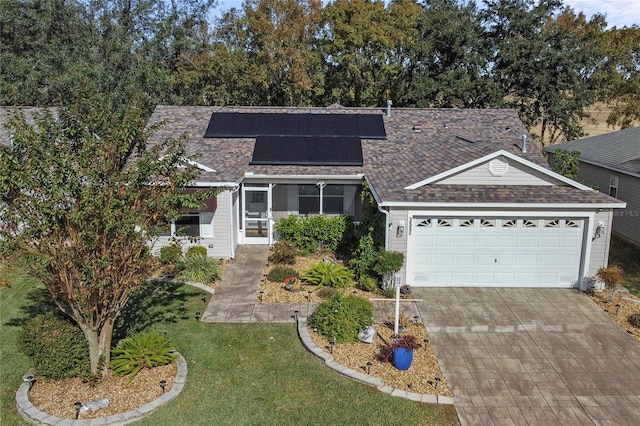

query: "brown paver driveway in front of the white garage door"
(413, 288), (640, 425)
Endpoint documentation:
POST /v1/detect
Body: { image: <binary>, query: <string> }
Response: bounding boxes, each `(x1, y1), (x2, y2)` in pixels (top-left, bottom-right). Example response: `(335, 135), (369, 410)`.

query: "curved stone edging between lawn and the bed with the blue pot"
(297, 317), (453, 404)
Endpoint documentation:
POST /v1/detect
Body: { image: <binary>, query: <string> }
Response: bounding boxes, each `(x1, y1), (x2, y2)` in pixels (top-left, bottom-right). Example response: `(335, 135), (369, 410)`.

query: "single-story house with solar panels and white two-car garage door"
(150, 104), (625, 289)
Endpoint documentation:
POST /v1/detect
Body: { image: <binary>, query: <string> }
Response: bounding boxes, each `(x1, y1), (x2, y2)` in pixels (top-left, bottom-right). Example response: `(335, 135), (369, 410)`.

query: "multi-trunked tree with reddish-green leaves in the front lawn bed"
(0, 109), (212, 373)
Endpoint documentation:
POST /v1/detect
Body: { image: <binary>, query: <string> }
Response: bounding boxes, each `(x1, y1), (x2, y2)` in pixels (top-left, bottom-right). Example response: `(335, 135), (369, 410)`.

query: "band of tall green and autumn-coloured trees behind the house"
(0, 0), (640, 144)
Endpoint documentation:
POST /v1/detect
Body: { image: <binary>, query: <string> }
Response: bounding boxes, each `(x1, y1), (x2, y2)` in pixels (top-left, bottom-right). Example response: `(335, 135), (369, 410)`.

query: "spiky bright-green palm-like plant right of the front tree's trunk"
(109, 331), (177, 379)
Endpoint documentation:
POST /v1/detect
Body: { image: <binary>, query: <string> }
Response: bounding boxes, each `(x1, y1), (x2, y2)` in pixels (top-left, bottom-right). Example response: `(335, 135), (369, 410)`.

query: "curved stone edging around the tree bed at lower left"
(16, 353), (187, 426)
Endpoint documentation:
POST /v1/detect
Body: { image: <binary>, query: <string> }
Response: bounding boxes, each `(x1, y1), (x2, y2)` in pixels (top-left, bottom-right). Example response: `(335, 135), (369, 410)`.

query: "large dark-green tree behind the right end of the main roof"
(484, 0), (605, 145)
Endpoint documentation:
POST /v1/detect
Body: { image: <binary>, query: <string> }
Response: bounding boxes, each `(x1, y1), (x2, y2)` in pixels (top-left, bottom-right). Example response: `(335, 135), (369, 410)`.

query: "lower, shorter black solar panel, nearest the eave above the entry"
(250, 136), (363, 166)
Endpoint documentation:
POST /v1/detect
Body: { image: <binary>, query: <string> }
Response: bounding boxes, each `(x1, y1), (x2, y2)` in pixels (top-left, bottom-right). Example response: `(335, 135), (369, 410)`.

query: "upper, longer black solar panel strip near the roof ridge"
(204, 112), (387, 139)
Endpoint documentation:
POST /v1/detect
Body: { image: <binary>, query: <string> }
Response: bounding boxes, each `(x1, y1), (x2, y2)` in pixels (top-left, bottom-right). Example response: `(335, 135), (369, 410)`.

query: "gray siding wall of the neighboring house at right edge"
(576, 163), (640, 246)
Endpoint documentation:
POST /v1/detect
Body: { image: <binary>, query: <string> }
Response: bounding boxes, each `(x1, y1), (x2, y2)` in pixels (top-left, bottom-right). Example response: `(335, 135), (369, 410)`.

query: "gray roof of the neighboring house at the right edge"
(545, 127), (640, 177)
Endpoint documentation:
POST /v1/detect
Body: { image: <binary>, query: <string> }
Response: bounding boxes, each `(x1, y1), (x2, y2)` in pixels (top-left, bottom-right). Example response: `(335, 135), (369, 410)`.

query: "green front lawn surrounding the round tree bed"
(0, 264), (458, 426)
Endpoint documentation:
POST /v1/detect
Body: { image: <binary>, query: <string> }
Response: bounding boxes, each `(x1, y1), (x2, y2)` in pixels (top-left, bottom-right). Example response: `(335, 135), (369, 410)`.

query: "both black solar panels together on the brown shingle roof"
(204, 112), (386, 166)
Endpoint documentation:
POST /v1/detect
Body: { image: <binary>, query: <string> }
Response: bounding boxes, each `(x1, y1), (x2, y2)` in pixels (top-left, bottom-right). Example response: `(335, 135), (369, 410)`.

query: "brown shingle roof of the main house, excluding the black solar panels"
(149, 106), (617, 205)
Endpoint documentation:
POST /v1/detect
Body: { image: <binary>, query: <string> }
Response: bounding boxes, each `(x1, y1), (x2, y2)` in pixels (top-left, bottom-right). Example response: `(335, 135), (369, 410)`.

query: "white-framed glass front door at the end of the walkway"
(242, 185), (271, 244)
